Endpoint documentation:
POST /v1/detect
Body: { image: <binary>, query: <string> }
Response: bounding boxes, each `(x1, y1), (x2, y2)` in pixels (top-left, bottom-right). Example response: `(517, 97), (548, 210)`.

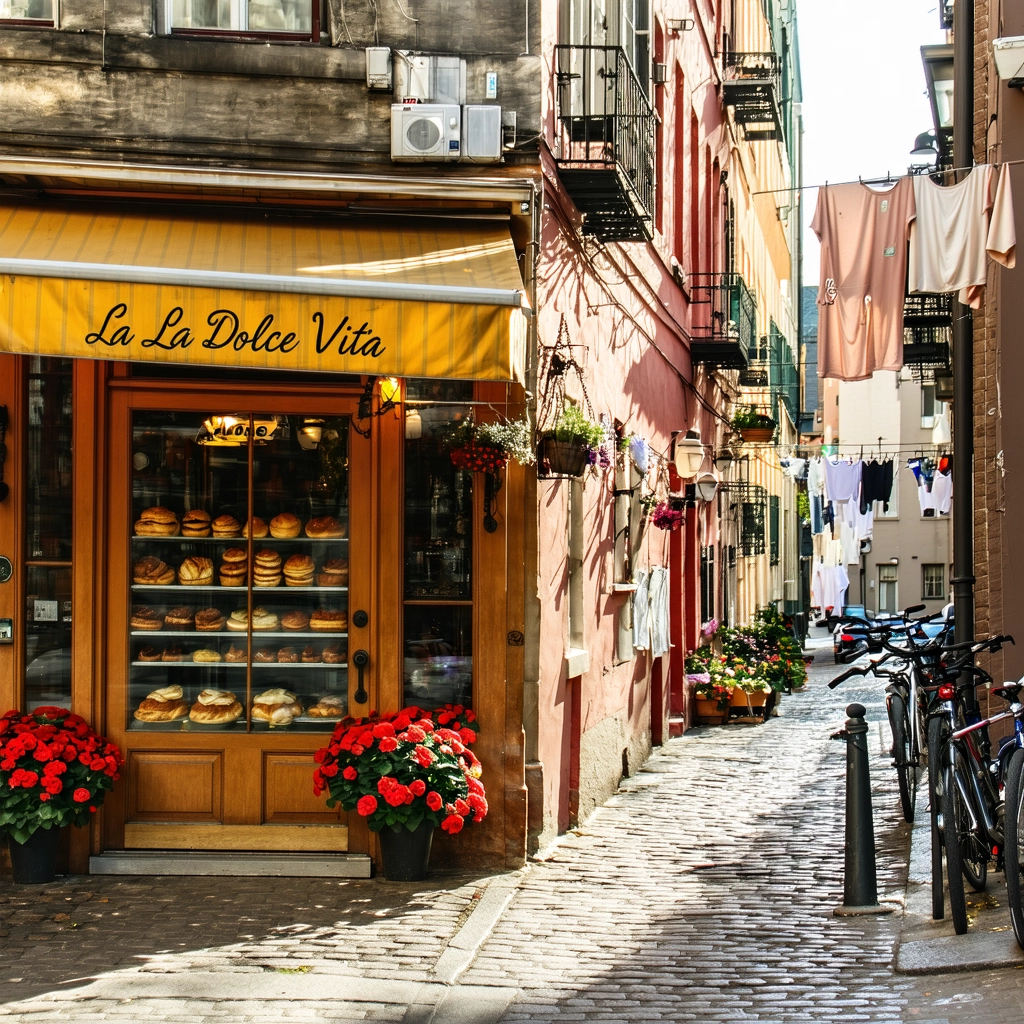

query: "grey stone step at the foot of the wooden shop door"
(89, 850), (373, 879)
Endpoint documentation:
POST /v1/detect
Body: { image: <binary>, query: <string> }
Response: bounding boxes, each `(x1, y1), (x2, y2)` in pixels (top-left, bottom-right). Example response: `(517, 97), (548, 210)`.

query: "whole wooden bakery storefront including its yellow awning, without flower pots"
(0, 195), (527, 874)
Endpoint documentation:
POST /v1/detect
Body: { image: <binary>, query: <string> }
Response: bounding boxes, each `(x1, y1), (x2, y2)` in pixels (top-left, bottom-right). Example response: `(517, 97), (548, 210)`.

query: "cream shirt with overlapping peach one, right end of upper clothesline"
(907, 164), (1017, 309)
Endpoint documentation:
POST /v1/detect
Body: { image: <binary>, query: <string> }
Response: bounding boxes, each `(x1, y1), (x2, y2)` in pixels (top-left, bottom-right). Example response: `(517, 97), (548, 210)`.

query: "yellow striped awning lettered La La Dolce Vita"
(0, 205), (528, 381)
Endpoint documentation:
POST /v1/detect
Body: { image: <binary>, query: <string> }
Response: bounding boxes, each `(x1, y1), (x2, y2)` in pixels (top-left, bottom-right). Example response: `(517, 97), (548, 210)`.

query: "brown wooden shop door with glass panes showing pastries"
(103, 382), (377, 851)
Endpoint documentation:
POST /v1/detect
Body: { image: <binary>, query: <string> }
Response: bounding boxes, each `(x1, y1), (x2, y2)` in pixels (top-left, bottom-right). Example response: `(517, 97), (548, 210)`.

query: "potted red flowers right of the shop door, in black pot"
(313, 705), (487, 882)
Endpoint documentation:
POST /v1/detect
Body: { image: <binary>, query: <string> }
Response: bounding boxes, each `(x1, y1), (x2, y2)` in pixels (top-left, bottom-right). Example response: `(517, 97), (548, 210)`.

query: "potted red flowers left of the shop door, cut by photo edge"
(0, 708), (124, 883)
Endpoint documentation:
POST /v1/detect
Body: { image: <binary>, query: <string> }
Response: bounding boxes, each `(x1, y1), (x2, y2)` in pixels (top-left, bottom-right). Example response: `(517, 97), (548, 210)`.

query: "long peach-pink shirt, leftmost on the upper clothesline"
(811, 178), (914, 381)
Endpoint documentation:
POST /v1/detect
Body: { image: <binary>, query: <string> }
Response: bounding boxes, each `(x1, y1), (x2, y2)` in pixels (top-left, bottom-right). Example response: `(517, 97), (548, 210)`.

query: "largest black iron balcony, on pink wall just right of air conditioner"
(555, 46), (655, 242)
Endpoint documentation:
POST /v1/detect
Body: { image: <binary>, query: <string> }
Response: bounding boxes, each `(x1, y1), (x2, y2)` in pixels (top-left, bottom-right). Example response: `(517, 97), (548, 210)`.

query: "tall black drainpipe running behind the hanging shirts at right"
(952, 0), (975, 643)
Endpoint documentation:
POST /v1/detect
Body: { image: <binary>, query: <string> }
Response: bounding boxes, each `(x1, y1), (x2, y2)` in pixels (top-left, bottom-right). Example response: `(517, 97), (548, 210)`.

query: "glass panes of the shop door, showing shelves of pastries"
(127, 411), (349, 732)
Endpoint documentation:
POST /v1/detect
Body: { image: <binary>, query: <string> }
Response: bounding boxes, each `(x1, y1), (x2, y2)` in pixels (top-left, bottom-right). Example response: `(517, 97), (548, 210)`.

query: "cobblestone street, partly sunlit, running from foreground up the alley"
(0, 655), (1022, 1024)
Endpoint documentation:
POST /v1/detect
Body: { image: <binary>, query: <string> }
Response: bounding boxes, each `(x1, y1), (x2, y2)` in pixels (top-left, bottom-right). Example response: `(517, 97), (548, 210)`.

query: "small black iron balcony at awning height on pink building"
(690, 273), (758, 372)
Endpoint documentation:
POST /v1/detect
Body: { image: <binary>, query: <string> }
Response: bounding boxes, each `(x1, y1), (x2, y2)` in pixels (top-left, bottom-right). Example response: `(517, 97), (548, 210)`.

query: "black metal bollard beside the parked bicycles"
(836, 703), (894, 915)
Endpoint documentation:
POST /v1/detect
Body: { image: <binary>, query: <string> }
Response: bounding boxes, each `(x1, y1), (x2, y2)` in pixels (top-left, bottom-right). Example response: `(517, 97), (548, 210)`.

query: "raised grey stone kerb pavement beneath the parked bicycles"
(894, 779), (1024, 974)
